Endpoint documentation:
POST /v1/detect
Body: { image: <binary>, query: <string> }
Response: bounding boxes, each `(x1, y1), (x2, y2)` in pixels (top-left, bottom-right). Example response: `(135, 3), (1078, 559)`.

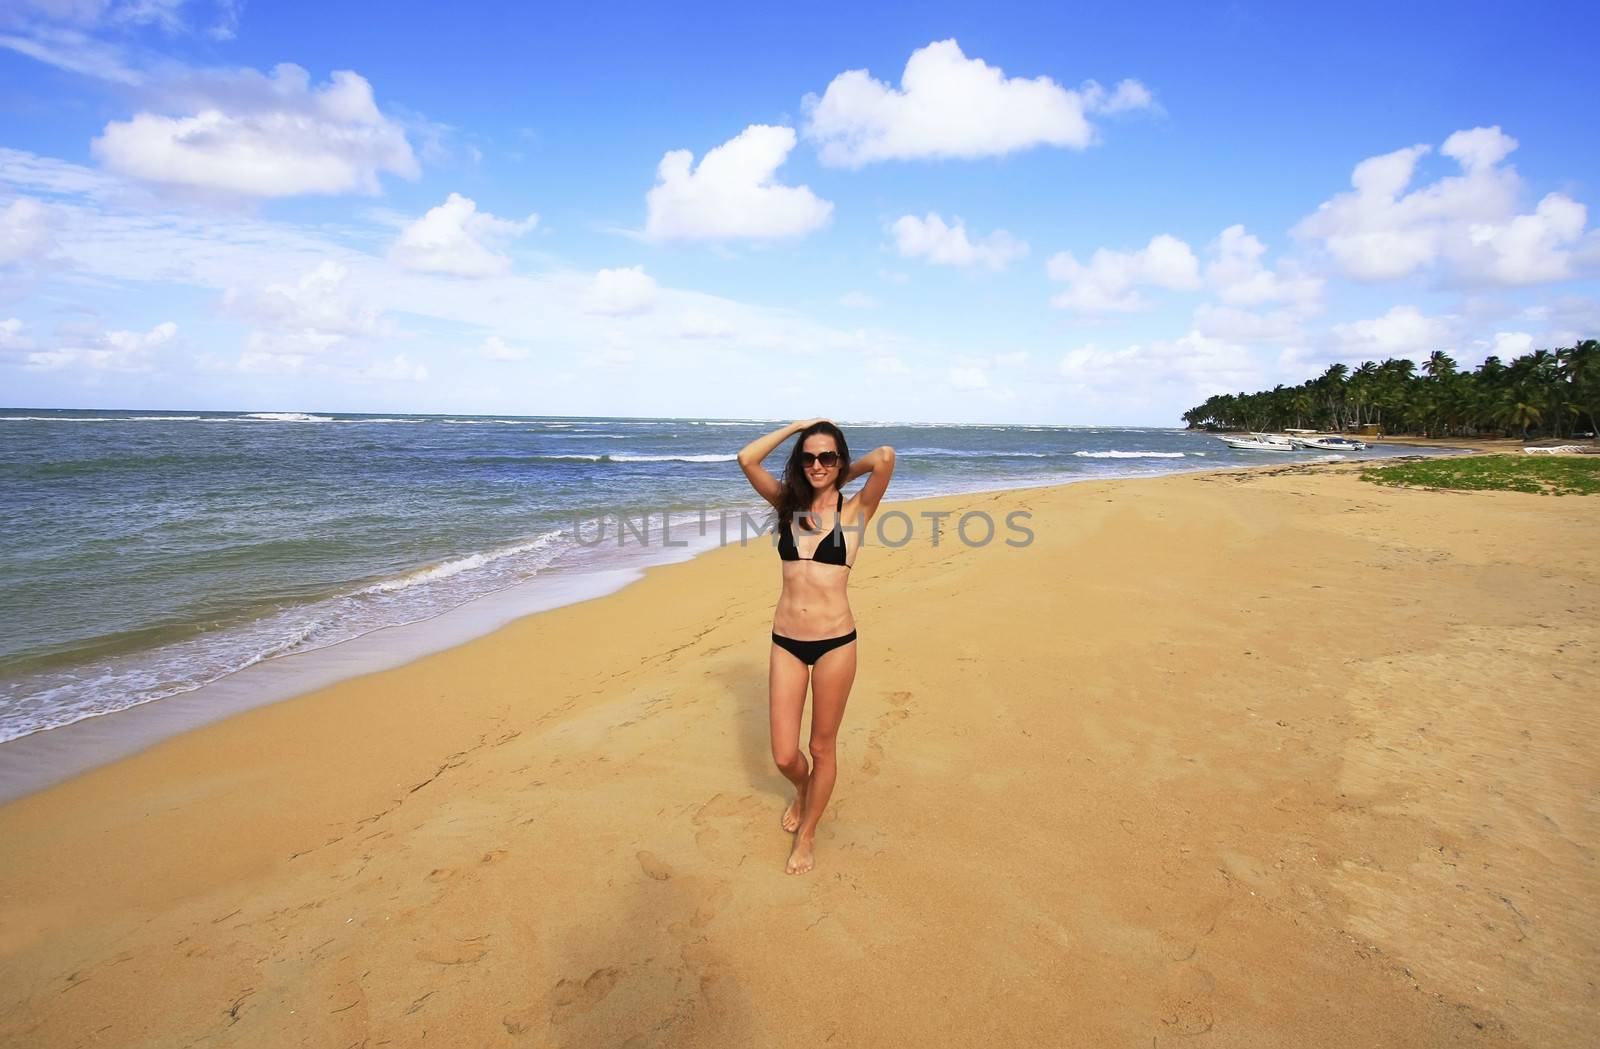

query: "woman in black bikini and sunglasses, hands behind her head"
(739, 419), (894, 875)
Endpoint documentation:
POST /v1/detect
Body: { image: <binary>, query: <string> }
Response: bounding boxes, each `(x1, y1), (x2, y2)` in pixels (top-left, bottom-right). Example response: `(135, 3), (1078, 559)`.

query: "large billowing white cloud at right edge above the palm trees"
(1294, 126), (1592, 285)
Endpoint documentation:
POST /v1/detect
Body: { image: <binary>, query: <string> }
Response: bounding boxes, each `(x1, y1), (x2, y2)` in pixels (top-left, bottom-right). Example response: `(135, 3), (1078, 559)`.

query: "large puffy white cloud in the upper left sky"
(90, 62), (419, 197)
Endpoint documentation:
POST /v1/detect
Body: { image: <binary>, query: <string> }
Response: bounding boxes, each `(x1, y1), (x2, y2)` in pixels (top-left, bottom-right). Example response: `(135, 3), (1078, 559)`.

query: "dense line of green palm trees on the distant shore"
(1182, 339), (1600, 438)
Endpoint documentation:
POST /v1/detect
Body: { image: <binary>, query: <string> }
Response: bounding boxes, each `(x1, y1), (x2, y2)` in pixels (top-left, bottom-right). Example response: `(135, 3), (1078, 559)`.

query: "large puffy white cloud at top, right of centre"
(802, 40), (1154, 168)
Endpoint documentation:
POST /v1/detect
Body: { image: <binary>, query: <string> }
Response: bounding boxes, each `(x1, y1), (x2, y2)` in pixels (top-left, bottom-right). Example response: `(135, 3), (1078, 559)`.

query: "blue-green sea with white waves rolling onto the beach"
(0, 409), (1452, 742)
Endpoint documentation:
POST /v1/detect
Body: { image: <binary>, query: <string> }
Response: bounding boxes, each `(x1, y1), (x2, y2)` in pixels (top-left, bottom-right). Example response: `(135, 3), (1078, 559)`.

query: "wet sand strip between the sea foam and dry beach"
(0, 445), (1450, 806)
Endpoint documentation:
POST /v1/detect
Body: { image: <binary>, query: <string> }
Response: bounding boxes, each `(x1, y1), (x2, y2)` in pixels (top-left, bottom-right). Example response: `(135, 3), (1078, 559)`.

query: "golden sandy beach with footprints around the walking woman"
(0, 462), (1600, 1049)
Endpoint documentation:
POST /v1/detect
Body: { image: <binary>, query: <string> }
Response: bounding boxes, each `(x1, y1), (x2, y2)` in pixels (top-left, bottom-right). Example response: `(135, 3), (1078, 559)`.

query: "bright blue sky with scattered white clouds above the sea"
(0, 0), (1600, 425)
